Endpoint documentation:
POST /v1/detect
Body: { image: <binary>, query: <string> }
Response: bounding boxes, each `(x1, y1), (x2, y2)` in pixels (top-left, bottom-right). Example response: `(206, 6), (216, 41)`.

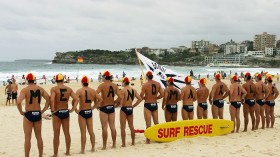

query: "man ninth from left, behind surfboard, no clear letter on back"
(197, 78), (209, 119)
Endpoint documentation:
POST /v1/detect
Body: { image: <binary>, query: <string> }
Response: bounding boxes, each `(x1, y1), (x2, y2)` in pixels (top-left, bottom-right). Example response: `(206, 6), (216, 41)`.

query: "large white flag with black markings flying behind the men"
(136, 52), (199, 89)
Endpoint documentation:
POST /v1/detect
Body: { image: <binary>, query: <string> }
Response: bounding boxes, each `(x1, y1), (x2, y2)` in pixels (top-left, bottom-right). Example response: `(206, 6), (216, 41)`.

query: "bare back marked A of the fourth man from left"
(96, 81), (119, 106)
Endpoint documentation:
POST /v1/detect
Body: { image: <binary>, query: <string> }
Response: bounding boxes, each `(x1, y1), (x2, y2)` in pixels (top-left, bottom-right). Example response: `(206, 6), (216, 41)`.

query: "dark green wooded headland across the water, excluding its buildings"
(52, 48), (280, 68)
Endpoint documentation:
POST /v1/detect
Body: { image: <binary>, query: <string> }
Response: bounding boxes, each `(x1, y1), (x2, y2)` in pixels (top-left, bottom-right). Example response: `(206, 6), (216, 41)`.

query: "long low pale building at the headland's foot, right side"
(204, 54), (245, 65)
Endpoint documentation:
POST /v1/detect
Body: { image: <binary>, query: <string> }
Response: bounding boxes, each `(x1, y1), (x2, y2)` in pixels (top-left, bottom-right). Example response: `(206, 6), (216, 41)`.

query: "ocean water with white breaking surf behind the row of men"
(0, 61), (280, 83)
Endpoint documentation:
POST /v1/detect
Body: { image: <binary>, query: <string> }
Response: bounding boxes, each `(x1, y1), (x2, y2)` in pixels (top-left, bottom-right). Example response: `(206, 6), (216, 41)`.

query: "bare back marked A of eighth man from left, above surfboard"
(181, 85), (197, 105)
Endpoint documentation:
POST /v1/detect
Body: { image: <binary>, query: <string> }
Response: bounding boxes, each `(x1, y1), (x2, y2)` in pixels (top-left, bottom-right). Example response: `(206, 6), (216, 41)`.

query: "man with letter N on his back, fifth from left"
(120, 77), (142, 147)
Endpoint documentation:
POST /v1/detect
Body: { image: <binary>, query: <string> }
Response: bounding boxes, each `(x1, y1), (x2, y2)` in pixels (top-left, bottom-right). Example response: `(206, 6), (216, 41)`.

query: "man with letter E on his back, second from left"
(50, 74), (78, 157)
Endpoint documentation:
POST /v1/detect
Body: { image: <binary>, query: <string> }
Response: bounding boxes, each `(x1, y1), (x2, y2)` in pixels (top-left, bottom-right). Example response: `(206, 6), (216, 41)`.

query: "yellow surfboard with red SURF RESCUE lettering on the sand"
(144, 119), (234, 142)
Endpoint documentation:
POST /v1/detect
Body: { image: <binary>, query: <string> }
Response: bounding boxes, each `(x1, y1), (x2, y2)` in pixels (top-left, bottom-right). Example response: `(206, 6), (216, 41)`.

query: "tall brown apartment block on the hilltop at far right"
(254, 32), (276, 51)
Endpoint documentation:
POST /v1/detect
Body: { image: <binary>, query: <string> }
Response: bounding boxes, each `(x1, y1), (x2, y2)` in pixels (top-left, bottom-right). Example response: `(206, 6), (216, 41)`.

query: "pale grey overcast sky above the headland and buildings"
(0, 0), (280, 61)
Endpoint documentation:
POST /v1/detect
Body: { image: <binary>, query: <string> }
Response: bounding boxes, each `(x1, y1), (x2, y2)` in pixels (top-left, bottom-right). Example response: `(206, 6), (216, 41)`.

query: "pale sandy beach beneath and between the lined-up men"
(0, 80), (280, 157)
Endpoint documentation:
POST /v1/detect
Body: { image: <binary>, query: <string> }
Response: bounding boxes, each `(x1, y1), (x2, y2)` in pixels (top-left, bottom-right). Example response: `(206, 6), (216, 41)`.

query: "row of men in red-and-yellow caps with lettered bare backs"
(8, 71), (279, 156)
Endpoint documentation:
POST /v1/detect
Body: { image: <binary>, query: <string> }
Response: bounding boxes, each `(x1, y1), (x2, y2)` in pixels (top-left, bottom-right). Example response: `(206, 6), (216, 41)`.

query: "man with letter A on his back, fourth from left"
(96, 71), (120, 150)
